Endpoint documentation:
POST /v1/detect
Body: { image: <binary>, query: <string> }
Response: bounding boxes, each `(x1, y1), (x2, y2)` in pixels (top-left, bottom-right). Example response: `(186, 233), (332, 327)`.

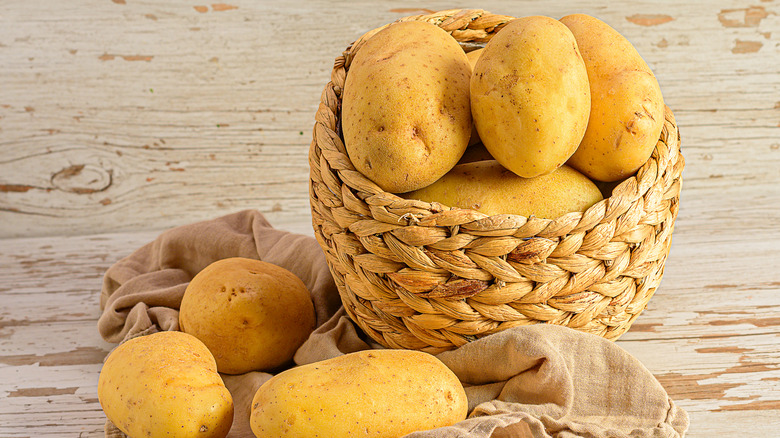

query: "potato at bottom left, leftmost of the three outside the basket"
(98, 331), (233, 438)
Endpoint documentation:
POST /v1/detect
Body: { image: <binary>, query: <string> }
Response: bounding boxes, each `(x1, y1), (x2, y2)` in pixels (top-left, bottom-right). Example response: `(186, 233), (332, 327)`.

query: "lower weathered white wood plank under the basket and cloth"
(0, 226), (780, 437)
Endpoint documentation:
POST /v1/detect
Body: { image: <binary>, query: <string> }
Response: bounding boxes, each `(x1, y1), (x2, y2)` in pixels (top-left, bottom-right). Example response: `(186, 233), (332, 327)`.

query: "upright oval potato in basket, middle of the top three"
(471, 16), (590, 178)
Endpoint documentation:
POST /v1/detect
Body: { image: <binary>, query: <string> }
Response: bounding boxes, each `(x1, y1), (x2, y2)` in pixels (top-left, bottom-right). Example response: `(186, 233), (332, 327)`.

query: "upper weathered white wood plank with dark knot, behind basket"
(0, 0), (780, 236)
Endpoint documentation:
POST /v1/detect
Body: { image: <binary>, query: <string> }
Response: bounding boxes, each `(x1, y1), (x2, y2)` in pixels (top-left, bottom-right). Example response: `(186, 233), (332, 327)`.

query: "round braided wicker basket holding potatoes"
(309, 10), (684, 353)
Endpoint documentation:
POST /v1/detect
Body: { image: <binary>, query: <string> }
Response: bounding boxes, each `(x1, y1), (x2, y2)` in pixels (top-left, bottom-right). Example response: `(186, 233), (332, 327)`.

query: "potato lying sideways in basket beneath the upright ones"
(403, 160), (603, 219)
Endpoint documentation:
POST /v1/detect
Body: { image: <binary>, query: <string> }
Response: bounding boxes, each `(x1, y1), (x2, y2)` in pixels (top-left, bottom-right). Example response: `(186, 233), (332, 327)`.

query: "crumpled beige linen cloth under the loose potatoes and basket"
(98, 210), (688, 438)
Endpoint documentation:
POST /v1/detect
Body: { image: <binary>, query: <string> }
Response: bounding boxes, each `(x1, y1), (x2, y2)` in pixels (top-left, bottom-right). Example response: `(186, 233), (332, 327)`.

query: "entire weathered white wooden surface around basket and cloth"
(0, 0), (780, 437)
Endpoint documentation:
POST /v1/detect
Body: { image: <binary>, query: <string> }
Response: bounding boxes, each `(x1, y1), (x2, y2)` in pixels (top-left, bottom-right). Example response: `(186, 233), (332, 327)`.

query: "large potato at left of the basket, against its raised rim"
(341, 21), (471, 193)
